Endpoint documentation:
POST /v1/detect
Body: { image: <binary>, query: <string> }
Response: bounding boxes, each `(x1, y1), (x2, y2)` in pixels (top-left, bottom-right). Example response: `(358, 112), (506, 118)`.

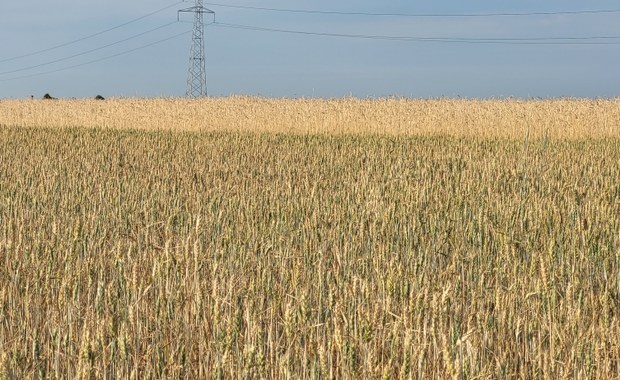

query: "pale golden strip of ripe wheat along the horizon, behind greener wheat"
(0, 97), (620, 139)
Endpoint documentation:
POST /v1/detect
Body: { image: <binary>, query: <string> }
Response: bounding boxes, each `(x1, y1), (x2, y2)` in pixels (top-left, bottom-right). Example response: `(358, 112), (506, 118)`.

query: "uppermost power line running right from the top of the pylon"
(205, 2), (620, 17)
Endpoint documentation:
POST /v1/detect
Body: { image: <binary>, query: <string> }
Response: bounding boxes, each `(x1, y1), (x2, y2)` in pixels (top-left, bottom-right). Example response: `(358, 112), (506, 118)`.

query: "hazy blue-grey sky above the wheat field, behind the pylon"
(0, 0), (620, 98)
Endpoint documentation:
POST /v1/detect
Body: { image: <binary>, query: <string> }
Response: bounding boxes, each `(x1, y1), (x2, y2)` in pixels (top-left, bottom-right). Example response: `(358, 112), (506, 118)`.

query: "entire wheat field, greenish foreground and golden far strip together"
(0, 97), (620, 379)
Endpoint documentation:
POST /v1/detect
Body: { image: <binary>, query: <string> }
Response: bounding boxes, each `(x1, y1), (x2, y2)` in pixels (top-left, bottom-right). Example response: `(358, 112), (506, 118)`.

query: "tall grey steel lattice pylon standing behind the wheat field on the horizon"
(179, 0), (215, 98)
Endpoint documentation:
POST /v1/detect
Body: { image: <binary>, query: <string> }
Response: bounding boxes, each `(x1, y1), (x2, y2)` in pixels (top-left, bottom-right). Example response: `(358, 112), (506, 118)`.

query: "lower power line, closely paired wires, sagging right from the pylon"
(214, 22), (620, 45)
